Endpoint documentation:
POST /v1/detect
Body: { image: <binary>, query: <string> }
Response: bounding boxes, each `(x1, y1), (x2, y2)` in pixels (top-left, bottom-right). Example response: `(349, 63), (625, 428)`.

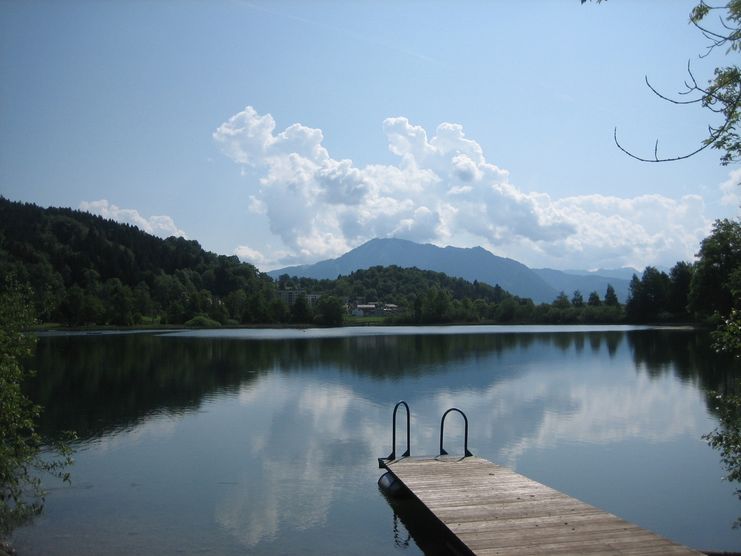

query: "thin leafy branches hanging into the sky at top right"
(581, 0), (741, 166)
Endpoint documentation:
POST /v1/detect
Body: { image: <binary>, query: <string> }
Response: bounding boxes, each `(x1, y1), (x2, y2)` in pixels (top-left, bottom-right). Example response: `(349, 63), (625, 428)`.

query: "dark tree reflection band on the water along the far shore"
(28, 330), (738, 441)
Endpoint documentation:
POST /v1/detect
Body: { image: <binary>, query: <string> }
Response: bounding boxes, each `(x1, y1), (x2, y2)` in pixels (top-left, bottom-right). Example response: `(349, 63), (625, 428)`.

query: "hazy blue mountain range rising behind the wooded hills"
(268, 238), (640, 303)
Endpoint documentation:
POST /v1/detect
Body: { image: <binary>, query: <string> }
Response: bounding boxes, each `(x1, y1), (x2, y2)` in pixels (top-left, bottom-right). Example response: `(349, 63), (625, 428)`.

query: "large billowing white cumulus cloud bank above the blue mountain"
(213, 106), (716, 268)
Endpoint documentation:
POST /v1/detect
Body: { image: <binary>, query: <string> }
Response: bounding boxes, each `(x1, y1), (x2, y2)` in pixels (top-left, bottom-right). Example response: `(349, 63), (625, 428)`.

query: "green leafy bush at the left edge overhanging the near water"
(0, 280), (72, 536)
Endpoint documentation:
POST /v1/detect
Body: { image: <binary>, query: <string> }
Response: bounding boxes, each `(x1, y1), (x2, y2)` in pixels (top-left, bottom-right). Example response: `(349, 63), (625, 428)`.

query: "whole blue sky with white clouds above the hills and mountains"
(0, 0), (741, 270)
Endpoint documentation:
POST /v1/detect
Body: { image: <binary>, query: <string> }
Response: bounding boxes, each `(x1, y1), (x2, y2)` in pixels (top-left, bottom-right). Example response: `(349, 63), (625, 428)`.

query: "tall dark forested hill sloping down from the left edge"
(0, 197), (275, 325)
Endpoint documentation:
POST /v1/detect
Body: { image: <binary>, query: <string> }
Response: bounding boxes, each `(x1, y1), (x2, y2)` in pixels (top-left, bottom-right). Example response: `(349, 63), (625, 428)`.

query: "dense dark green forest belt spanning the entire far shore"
(0, 197), (741, 326)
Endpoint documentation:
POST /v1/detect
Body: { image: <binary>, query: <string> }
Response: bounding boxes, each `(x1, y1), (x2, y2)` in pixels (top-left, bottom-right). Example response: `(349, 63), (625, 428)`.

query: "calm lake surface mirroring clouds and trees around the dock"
(14, 327), (741, 554)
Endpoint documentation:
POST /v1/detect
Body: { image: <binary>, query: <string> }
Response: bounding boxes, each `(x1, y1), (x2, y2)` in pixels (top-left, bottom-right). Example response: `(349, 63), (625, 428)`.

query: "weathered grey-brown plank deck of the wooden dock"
(386, 457), (700, 556)
